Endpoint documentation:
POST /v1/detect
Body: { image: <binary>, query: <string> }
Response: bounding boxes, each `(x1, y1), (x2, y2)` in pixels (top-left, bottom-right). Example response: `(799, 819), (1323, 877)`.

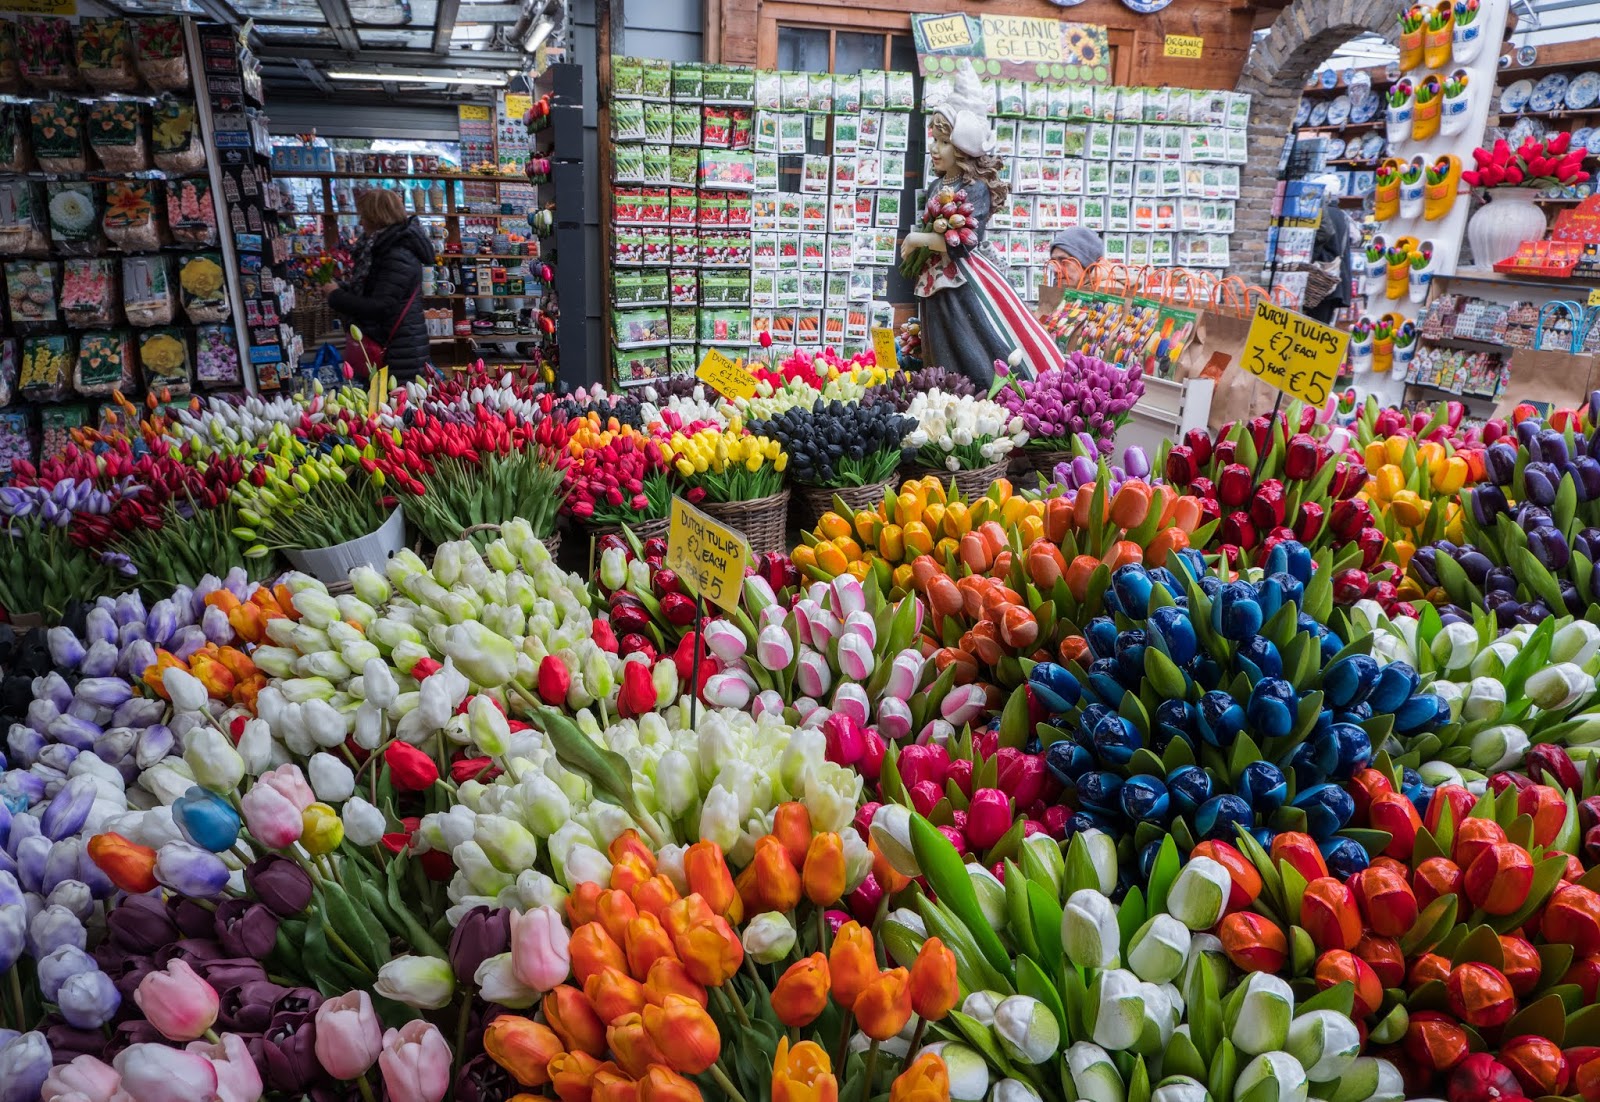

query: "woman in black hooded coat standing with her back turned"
(328, 189), (434, 377)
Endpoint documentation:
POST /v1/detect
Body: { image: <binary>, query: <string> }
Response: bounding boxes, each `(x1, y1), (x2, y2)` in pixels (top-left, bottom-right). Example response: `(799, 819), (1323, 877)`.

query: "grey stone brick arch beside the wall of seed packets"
(1229, 0), (1398, 283)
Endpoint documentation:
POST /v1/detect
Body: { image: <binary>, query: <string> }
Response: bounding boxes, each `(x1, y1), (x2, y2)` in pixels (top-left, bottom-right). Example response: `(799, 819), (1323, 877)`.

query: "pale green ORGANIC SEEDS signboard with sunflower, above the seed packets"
(910, 14), (1110, 83)
